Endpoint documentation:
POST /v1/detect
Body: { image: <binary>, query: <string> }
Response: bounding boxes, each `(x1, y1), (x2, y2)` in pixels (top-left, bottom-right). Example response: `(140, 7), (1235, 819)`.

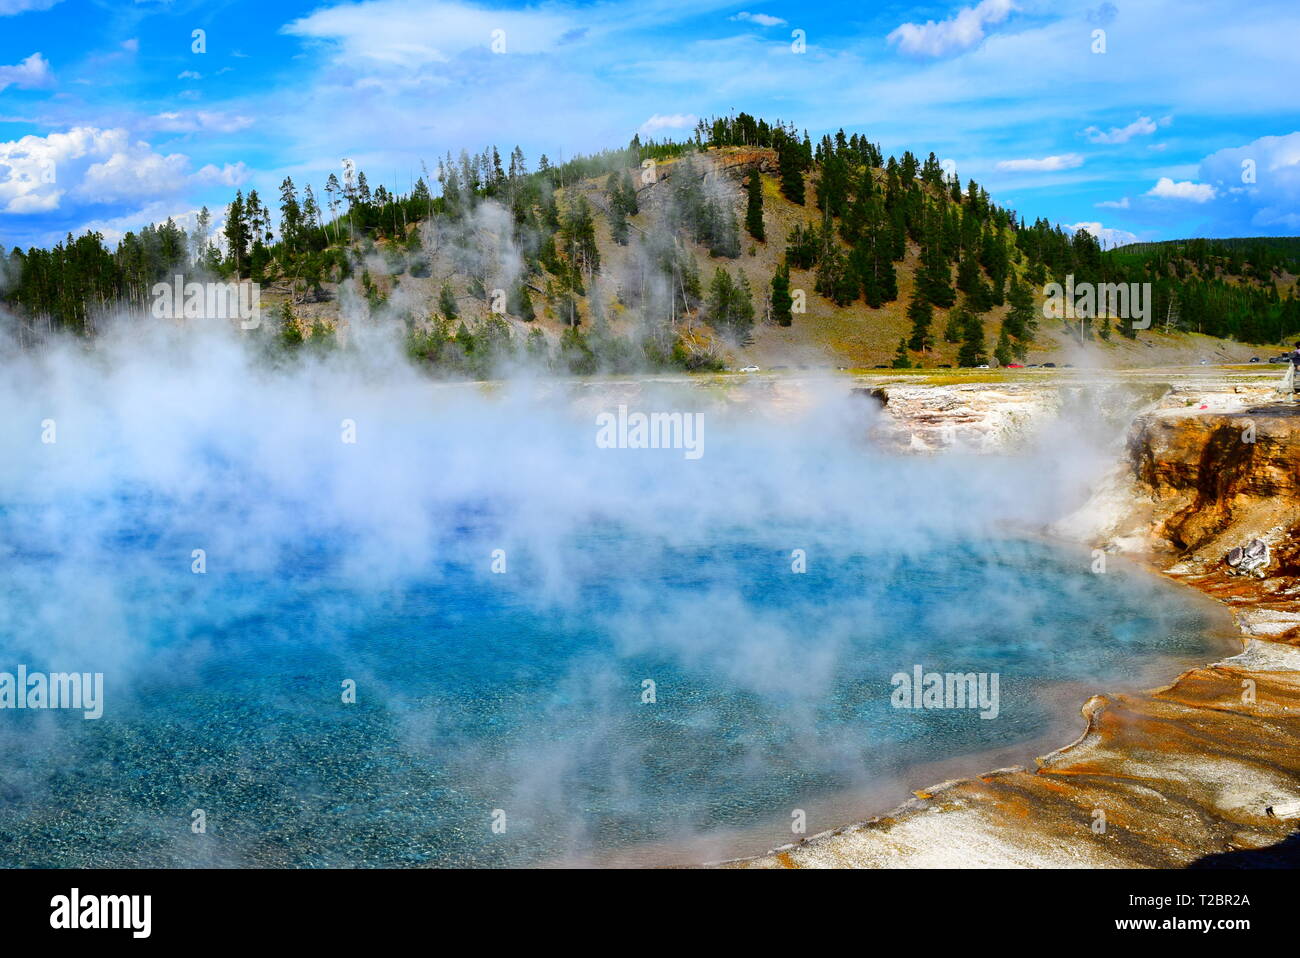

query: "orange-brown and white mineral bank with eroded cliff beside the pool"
(728, 387), (1300, 868)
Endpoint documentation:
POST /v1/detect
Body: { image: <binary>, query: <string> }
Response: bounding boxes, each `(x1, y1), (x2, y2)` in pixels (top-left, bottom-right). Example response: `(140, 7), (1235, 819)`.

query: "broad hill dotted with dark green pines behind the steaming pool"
(0, 113), (1300, 377)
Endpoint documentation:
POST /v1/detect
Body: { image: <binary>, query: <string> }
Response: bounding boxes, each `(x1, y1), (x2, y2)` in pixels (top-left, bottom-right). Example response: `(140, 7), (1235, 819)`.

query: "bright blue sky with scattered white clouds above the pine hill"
(0, 0), (1300, 247)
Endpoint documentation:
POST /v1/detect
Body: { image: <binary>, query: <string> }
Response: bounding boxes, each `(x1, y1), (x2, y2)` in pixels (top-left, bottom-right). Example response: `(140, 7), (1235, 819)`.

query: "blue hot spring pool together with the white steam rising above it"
(0, 323), (1209, 866)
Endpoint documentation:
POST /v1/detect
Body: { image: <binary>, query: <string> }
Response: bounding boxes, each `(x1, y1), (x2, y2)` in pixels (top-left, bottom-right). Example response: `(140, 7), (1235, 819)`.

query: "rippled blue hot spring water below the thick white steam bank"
(0, 509), (1227, 867)
